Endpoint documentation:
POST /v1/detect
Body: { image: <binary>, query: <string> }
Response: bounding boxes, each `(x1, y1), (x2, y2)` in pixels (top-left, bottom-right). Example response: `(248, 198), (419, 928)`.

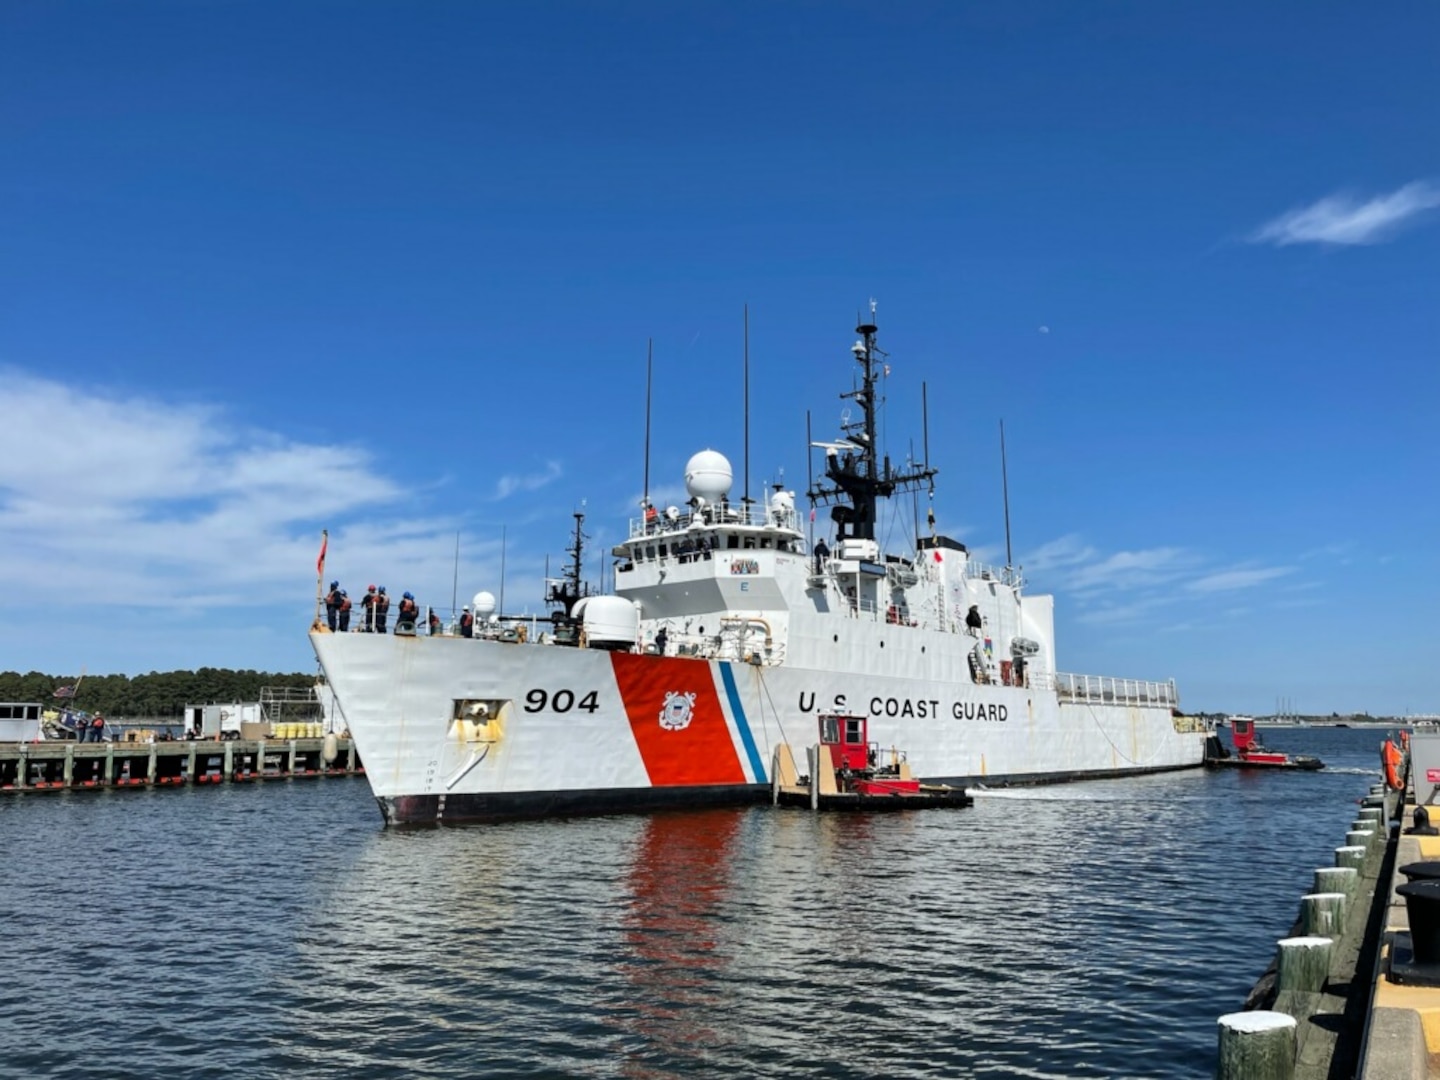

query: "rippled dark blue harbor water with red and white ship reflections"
(0, 729), (1382, 1080)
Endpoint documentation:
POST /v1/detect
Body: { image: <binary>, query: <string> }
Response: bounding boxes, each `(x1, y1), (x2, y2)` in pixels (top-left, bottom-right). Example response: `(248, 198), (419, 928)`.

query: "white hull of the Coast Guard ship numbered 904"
(311, 631), (1207, 824)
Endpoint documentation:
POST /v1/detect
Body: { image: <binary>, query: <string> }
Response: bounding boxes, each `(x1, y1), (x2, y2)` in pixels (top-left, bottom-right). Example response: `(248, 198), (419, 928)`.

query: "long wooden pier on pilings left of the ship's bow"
(0, 739), (364, 792)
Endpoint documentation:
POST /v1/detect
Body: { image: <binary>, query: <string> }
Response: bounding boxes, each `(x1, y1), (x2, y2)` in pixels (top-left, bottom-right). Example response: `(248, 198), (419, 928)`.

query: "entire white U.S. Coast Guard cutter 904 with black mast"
(311, 321), (1208, 824)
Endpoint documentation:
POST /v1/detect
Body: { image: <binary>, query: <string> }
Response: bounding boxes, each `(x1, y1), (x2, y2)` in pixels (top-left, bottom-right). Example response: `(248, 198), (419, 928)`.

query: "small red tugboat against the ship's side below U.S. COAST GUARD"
(770, 713), (975, 809)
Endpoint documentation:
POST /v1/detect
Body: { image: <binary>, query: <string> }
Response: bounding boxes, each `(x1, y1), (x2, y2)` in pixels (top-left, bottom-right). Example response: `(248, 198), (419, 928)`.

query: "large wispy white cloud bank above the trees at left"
(0, 370), (498, 619)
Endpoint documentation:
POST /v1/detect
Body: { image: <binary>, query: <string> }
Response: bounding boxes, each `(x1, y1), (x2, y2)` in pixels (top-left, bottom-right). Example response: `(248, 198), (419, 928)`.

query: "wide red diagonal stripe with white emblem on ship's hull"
(611, 652), (746, 788)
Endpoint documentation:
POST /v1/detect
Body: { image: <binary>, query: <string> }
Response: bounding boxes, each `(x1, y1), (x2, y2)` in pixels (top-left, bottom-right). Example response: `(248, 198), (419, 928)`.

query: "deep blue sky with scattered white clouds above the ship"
(0, 1), (1440, 714)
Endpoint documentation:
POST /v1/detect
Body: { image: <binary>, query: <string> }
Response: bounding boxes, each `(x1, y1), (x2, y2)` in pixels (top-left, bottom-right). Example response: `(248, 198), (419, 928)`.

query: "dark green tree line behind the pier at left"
(0, 668), (315, 720)
